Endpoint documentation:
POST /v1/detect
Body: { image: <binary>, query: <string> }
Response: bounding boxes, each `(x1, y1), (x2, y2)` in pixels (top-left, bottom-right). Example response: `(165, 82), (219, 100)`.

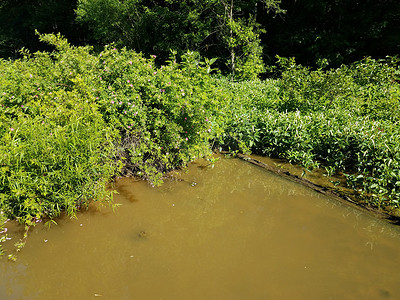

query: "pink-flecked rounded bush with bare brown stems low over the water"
(95, 47), (223, 182)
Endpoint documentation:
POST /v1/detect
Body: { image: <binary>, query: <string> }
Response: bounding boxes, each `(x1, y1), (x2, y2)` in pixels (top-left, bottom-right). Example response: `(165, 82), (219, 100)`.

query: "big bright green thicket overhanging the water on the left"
(0, 35), (223, 255)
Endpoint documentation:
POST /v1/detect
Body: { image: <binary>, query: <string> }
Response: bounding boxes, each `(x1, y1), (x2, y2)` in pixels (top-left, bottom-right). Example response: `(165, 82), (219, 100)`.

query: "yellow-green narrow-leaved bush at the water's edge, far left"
(0, 93), (116, 225)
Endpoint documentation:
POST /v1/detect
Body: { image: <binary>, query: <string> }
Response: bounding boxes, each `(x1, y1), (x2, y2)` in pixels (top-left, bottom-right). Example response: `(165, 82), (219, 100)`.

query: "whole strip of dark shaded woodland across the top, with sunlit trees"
(0, 0), (400, 69)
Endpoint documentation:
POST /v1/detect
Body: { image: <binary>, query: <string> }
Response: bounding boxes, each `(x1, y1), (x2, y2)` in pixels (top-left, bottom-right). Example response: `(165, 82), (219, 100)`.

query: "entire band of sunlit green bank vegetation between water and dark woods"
(0, 35), (400, 254)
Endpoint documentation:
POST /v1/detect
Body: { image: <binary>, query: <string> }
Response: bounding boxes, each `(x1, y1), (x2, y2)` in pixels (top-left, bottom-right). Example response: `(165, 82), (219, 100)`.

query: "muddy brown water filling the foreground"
(0, 159), (400, 299)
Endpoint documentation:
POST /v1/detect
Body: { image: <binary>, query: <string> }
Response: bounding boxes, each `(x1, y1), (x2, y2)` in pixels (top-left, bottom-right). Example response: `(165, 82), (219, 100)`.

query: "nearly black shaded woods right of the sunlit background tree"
(258, 0), (400, 67)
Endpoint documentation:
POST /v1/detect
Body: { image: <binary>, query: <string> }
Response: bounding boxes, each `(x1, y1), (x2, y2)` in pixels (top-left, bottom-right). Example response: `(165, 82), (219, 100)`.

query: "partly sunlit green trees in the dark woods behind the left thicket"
(76, 0), (281, 78)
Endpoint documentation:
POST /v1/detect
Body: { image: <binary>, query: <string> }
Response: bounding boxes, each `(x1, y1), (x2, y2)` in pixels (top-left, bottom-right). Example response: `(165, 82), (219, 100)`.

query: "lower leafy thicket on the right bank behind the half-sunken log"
(218, 58), (400, 213)
